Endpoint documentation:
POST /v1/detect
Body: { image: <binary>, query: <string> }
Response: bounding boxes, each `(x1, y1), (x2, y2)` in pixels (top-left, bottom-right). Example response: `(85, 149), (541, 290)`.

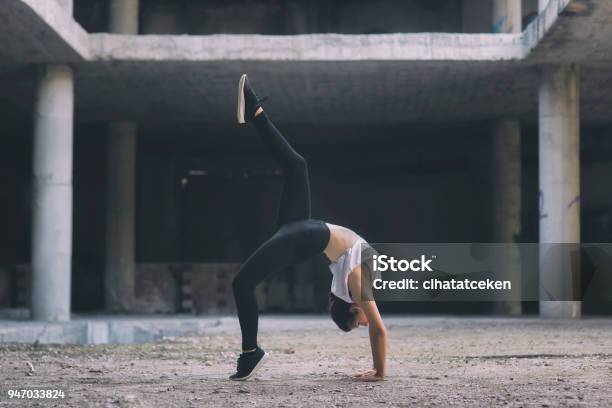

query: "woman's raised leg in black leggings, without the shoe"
(253, 112), (310, 227)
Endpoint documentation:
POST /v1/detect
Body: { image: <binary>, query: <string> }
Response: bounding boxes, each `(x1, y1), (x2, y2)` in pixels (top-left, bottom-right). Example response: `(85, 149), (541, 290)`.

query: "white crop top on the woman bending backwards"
(327, 224), (367, 303)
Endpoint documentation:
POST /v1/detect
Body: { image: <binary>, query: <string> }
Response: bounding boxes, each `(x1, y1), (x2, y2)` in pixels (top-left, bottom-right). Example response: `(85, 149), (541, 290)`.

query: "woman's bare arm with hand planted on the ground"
(348, 266), (387, 381)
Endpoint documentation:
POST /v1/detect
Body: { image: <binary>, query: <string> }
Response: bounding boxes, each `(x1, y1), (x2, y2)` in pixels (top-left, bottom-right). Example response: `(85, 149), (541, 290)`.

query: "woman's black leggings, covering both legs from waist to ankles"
(232, 112), (330, 350)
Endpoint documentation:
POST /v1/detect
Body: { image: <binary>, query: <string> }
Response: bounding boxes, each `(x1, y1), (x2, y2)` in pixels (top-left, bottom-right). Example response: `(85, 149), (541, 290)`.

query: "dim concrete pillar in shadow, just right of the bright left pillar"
(104, 122), (136, 311)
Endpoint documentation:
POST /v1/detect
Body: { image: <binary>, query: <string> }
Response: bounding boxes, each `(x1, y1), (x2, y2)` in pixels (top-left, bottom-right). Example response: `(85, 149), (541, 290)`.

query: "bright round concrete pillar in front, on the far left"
(31, 65), (74, 321)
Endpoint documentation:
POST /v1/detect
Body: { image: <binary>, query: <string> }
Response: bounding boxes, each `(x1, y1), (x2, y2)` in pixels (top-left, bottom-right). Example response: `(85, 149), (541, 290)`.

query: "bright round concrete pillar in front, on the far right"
(539, 65), (581, 318)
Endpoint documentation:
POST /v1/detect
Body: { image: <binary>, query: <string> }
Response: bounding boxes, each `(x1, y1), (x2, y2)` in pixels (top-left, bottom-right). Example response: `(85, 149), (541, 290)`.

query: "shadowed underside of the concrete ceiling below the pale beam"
(76, 61), (537, 124)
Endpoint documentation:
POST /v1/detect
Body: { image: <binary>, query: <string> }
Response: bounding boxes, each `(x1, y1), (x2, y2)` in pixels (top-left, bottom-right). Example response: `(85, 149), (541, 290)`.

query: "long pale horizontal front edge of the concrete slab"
(90, 33), (524, 62)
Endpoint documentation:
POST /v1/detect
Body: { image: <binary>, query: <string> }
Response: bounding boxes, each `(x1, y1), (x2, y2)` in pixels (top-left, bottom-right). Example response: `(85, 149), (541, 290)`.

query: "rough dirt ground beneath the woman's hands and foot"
(0, 317), (612, 407)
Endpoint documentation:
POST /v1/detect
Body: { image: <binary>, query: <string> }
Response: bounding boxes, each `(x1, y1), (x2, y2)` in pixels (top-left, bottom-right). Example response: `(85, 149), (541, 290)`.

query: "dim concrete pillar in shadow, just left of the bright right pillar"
(492, 119), (522, 315)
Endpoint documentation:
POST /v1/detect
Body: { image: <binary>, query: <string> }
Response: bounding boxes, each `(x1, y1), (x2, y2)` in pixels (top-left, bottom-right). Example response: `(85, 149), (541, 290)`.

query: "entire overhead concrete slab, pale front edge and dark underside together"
(0, 0), (612, 126)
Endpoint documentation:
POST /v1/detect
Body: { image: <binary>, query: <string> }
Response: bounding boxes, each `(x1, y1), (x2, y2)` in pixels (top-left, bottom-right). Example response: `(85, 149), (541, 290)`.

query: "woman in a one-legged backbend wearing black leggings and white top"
(230, 75), (387, 381)
